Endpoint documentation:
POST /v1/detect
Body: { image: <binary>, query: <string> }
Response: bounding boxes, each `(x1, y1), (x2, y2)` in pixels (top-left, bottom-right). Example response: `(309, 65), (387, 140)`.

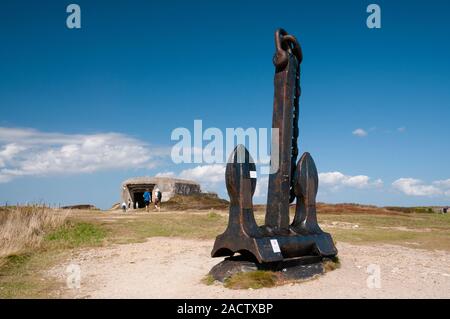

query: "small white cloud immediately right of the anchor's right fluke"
(319, 172), (383, 189)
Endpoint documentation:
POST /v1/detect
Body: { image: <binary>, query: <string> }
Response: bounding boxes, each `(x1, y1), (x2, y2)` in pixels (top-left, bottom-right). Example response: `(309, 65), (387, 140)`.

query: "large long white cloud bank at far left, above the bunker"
(0, 127), (165, 182)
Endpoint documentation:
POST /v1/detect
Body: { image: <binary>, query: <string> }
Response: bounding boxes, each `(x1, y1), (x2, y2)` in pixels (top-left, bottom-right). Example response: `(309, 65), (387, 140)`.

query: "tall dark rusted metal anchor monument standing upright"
(211, 29), (337, 263)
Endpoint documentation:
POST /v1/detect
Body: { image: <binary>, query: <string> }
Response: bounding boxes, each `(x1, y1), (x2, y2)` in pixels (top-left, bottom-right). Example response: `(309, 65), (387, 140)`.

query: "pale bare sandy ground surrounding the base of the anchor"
(48, 238), (450, 298)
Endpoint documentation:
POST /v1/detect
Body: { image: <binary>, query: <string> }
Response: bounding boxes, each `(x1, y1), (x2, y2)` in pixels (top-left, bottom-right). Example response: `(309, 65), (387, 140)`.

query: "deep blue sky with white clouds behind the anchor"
(0, 0), (450, 208)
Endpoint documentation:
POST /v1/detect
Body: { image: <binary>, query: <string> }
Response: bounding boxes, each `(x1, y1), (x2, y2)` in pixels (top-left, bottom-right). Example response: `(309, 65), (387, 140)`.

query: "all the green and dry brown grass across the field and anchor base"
(0, 201), (450, 298)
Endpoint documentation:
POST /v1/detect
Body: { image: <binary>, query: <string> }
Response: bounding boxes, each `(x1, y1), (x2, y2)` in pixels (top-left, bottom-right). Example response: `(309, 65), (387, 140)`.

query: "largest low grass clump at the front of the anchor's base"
(224, 270), (279, 289)
